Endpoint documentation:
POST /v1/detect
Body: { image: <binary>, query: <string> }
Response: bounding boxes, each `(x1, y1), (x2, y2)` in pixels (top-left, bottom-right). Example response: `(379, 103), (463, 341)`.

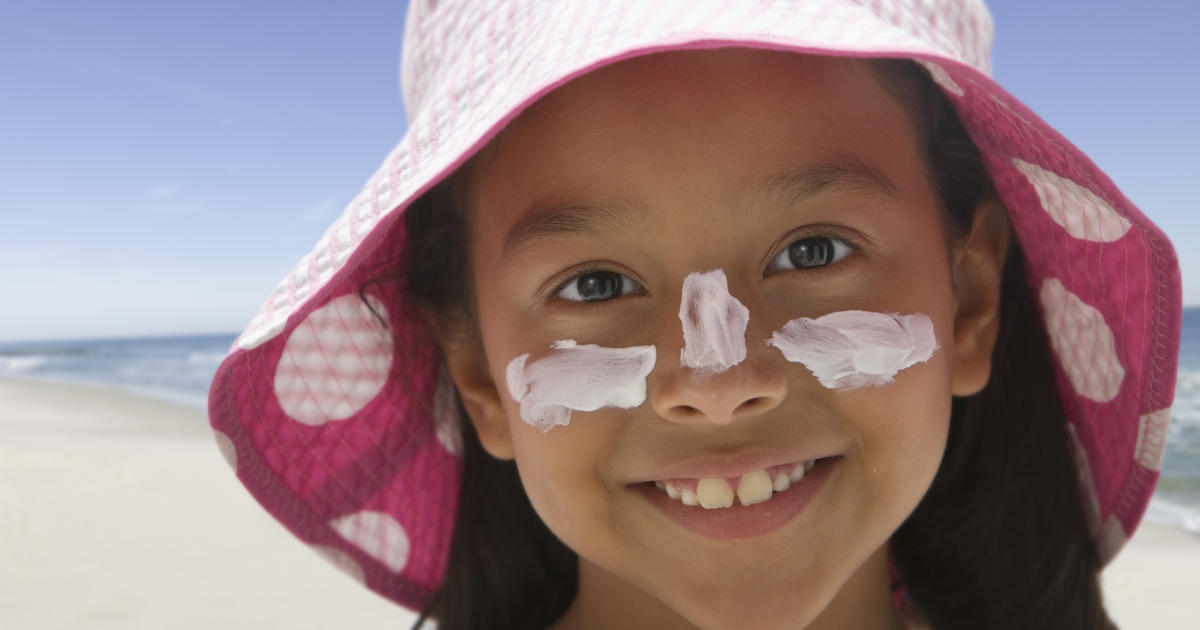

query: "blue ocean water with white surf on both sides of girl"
(0, 307), (1200, 535)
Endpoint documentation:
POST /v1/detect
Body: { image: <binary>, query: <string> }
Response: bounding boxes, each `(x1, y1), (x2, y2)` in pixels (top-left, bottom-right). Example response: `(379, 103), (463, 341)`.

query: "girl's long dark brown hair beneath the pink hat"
(404, 60), (1112, 630)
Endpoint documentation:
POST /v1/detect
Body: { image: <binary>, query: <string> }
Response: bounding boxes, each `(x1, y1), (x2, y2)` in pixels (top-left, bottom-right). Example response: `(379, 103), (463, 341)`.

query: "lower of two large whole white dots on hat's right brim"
(1040, 278), (1124, 402)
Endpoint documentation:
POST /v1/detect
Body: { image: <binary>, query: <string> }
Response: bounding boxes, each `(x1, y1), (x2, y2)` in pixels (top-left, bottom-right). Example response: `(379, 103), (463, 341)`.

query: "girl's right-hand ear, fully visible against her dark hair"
(953, 198), (1012, 396)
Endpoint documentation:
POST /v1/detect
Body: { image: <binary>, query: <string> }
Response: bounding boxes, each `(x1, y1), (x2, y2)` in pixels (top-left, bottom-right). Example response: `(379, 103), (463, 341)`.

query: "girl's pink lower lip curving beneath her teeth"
(631, 457), (841, 540)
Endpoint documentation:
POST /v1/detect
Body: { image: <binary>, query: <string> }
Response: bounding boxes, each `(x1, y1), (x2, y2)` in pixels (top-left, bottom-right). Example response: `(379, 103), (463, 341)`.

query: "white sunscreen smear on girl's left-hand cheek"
(505, 340), (655, 432)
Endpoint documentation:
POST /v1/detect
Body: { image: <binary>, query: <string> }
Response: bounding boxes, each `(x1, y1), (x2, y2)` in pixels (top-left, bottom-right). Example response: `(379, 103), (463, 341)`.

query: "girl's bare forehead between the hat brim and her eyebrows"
(472, 48), (924, 228)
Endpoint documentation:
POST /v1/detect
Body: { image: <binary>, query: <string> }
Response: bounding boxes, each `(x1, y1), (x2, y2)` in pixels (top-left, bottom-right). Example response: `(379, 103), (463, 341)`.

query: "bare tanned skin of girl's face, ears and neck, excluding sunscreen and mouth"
(439, 49), (1008, 629)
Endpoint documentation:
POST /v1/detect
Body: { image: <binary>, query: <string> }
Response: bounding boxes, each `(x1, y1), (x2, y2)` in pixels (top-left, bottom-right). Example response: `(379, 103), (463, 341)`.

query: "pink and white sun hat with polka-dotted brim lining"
(209, 0), (1181, 608)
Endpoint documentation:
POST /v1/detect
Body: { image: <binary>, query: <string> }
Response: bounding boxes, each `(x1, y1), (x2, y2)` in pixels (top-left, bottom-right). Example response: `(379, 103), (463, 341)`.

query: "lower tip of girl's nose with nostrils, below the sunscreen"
(649, 356), (787, 425)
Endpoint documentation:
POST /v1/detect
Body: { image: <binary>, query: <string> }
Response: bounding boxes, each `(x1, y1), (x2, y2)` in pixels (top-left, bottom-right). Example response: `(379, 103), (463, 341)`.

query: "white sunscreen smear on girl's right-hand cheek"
(767, 311), (937, 389)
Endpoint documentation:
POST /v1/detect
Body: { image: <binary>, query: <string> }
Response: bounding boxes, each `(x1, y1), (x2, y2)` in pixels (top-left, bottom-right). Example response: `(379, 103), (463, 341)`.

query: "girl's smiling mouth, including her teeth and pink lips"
(631, 456), (841, 540)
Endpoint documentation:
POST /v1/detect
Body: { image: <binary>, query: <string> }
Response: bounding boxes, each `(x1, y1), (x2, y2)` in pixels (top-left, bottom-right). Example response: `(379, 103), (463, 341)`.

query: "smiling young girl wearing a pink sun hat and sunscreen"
(210, 0), (1180, 629)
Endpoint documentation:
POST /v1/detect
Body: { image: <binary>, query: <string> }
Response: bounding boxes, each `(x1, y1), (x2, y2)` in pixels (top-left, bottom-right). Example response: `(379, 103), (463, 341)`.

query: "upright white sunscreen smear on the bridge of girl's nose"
(679, 269), (750, 372)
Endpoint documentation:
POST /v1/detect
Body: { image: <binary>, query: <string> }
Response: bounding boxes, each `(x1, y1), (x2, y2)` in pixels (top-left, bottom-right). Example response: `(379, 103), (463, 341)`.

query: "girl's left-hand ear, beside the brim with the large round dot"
(425, 310), (512, 460)
